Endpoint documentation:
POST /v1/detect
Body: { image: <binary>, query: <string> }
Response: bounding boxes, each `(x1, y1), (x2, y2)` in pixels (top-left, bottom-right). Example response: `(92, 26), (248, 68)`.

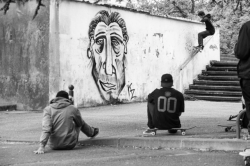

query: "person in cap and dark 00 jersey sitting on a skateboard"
(143, 74), (184, 135)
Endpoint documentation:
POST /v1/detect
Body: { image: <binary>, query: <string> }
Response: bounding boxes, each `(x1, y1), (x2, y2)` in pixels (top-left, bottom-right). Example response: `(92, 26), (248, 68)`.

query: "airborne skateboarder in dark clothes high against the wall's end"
(195, 11), (215, 50)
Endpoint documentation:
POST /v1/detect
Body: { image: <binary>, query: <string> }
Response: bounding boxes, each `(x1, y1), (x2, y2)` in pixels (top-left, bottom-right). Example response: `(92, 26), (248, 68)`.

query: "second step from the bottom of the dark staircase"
(185, 90), (242, 97)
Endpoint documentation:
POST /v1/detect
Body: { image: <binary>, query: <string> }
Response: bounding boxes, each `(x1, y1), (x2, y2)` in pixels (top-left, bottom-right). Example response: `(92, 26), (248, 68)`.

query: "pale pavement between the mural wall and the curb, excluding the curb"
(0, 101), (241, 141)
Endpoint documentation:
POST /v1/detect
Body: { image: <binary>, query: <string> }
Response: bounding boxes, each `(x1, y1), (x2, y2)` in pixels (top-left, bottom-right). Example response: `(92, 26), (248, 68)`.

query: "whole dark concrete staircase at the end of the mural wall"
(184, 54), (242, 102)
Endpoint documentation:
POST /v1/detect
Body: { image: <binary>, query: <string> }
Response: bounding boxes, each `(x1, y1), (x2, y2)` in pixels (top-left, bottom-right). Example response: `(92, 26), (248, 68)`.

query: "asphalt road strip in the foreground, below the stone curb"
(0, 143), (244, 166)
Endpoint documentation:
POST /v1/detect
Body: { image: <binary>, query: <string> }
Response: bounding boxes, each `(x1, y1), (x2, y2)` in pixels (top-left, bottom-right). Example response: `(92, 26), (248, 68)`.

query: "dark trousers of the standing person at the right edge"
(240, 78), (250, 132)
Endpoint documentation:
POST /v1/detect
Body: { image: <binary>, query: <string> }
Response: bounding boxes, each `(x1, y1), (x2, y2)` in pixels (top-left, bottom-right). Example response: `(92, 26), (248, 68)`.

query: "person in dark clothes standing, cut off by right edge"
(234, 21), (250, 142)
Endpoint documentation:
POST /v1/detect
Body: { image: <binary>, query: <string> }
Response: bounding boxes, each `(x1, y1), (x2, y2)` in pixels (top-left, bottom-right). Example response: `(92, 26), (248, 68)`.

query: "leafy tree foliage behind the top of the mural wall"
(124, 0), (250, 53)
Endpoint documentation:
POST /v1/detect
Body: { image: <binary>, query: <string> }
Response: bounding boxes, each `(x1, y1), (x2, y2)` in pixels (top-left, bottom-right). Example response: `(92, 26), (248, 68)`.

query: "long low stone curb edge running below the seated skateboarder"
(79, 137), (250, 151)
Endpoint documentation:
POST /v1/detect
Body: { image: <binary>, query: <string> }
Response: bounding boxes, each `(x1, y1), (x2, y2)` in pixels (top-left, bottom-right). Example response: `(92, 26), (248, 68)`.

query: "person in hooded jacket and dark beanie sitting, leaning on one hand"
(34, 91), (99, 154)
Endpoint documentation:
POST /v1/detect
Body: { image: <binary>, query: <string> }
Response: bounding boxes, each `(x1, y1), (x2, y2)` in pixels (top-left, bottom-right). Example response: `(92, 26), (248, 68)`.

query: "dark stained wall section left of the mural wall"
(0, 0), (49, 110)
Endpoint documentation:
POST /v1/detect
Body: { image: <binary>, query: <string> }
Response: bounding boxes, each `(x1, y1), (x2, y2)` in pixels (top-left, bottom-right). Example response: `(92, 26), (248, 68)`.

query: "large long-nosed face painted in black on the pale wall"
(87, 10), (128, 101)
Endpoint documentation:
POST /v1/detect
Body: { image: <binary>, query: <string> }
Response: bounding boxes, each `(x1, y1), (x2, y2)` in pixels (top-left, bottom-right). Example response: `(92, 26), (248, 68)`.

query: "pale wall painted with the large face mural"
(49, 0), (220, 107)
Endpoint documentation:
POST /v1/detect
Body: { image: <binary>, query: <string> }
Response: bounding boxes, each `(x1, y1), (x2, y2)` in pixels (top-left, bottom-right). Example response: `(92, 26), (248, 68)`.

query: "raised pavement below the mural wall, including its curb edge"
(0, 101), (250, 150)
